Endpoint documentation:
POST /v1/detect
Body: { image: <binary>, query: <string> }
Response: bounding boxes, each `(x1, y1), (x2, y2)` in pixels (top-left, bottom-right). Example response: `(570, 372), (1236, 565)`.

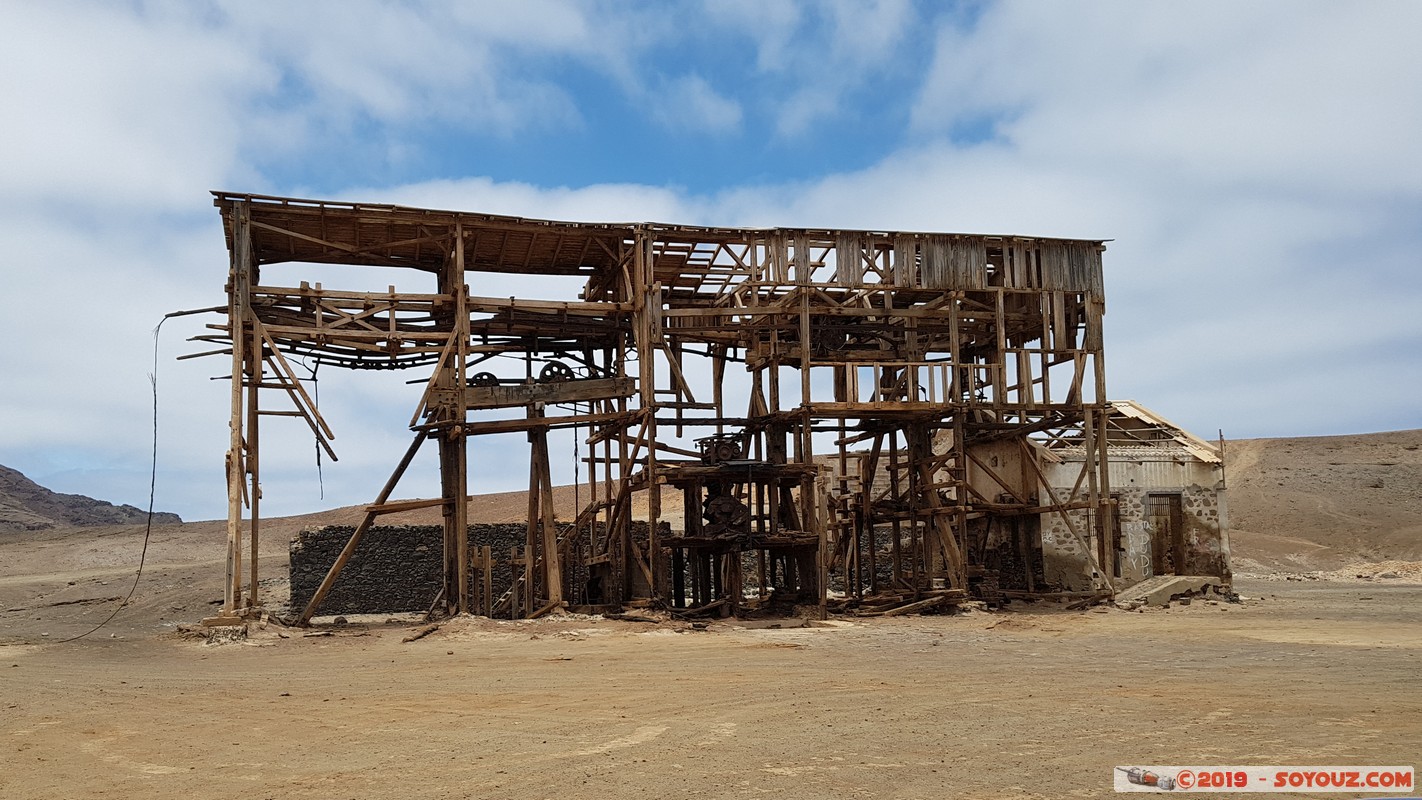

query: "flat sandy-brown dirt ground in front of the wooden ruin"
(0, 567), (1422, 799)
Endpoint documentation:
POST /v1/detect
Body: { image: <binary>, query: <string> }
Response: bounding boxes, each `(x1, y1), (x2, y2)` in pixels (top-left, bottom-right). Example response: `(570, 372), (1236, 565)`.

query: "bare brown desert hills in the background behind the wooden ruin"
(0, 431), (1422, 637)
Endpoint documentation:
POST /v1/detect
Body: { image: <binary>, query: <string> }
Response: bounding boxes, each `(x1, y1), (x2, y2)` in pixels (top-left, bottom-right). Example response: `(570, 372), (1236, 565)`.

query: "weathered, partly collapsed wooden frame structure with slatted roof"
(199, 192), (1111, 622)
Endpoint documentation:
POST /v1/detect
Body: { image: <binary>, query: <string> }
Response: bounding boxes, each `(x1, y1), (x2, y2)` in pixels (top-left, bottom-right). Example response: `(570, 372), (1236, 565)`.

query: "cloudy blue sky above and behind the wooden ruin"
(0, 0), (1422, 519)
